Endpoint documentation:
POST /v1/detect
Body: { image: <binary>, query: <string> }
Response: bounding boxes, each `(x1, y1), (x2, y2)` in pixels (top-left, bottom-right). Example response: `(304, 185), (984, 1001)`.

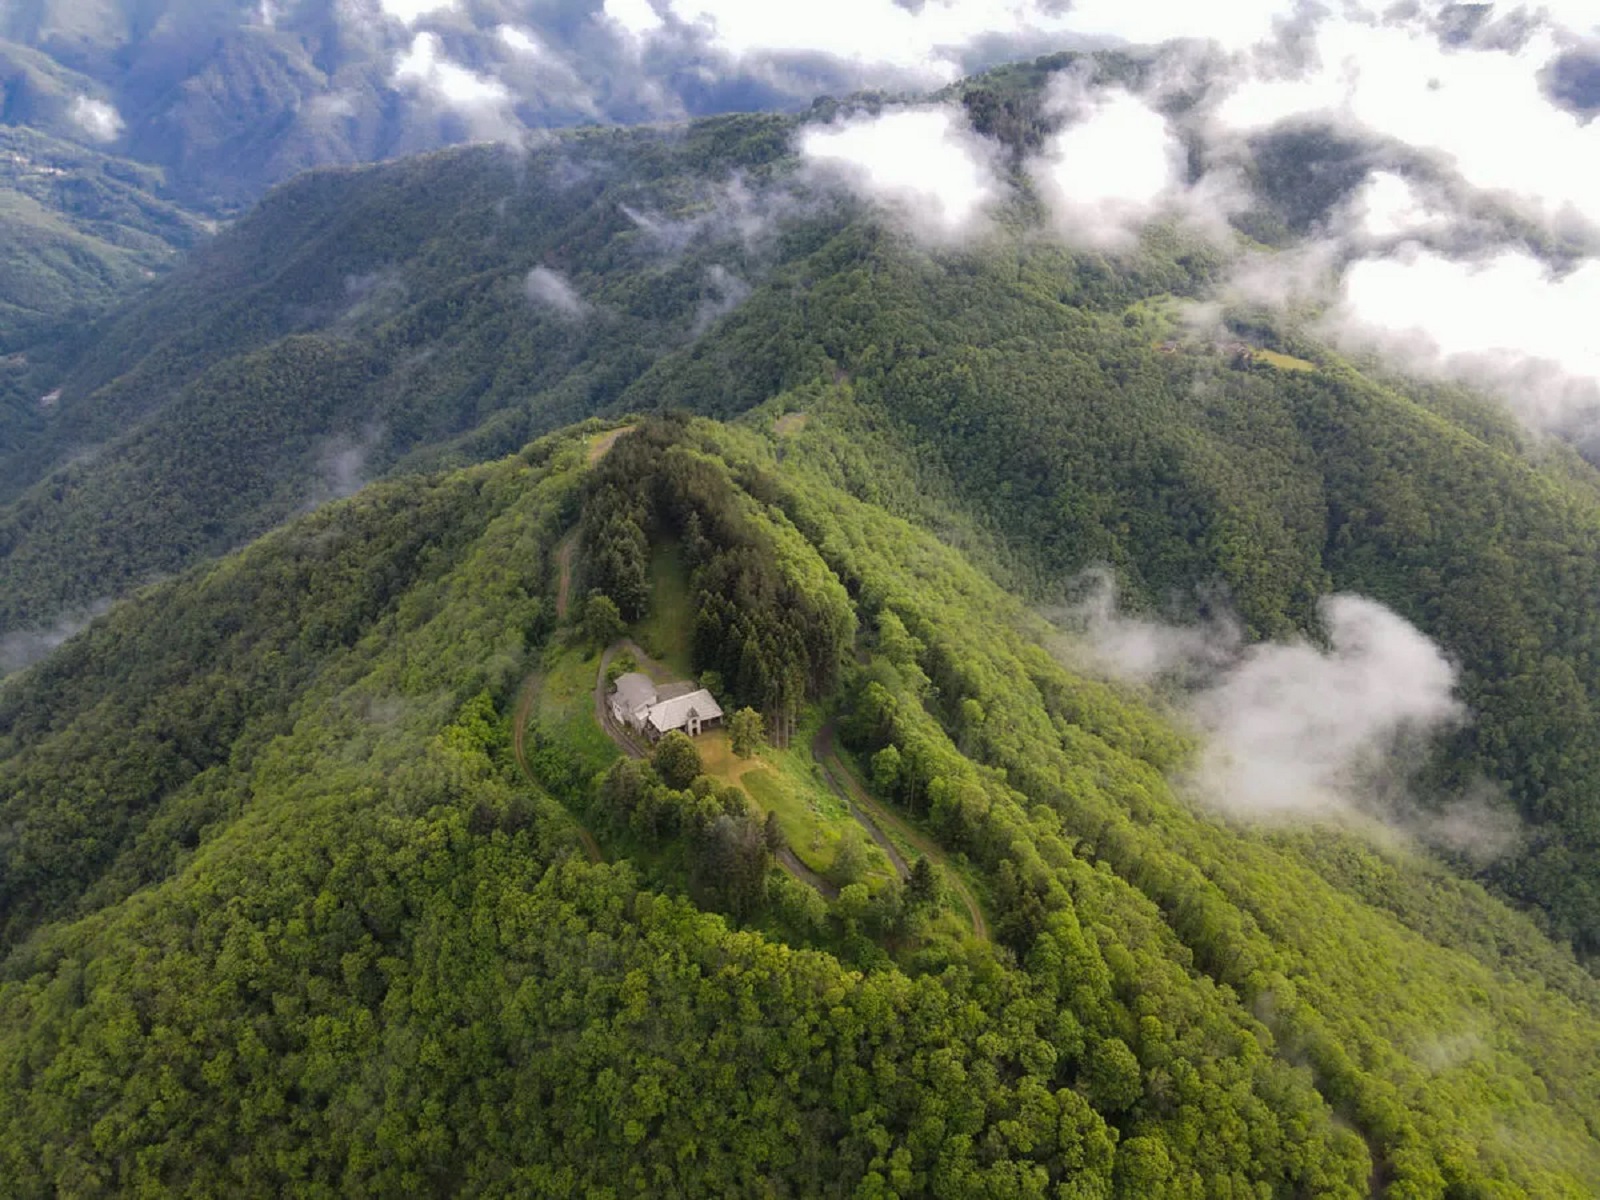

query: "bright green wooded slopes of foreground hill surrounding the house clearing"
(0, 419), (1600, 1197)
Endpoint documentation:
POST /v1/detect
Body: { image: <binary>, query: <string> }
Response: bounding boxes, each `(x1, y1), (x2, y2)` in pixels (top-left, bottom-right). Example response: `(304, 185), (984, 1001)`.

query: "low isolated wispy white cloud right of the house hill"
(1059, 582), (1484, 854)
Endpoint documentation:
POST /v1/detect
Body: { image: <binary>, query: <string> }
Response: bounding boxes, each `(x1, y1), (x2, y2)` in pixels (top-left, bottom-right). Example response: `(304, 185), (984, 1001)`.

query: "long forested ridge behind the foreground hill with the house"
(0, 80), (1600, 954)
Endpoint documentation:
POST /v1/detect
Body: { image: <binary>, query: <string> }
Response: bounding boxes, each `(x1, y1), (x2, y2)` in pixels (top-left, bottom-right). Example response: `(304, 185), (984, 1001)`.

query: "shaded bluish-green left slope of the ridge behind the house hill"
(0, 118), (825, 611)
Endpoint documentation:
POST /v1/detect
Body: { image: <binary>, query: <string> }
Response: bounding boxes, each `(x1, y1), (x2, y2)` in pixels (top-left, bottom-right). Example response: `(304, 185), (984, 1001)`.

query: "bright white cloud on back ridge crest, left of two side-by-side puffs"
(800, 107), (1002, 242)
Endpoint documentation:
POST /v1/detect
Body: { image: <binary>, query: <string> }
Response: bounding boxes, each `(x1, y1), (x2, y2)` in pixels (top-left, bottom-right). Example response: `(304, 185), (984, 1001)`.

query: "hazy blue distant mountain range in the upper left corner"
(0, 0), (758, 339)
